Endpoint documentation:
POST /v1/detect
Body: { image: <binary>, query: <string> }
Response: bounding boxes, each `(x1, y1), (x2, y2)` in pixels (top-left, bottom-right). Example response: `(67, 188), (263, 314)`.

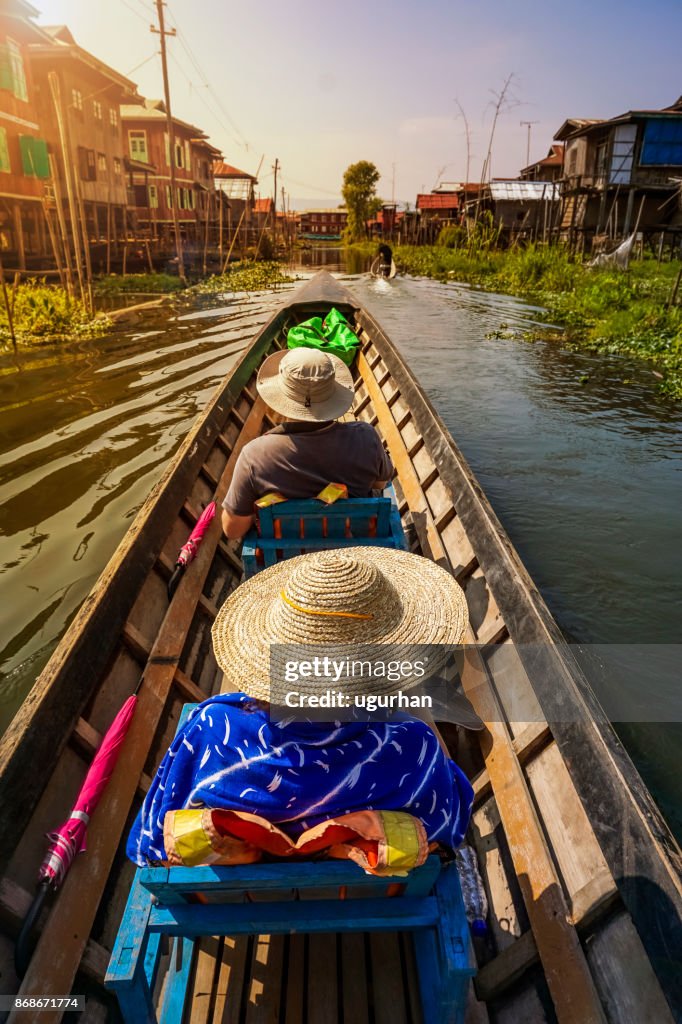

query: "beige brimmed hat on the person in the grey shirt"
(256, 348), (355, 423)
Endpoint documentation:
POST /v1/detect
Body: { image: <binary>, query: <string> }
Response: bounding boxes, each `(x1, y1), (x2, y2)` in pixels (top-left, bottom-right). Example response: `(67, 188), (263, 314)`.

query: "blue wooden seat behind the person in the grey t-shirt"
(242, 484), (408, 580)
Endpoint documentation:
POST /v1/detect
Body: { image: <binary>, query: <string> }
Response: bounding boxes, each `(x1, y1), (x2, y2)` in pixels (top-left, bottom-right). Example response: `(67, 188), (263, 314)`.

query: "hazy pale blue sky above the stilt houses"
(32, 0), (682, 209)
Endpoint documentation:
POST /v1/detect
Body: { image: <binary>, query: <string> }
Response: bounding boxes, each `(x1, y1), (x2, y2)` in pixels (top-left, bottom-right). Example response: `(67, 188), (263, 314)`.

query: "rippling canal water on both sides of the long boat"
(0, 250), (682, 835)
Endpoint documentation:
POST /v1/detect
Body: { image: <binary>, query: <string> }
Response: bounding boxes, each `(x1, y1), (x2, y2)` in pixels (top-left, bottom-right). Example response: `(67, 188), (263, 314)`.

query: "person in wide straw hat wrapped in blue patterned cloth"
(127, 547), (473, 865)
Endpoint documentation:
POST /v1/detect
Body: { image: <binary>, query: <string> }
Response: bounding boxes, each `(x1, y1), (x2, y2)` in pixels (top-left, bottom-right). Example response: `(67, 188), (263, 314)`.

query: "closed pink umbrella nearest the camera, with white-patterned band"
(14, 696), (141, 978)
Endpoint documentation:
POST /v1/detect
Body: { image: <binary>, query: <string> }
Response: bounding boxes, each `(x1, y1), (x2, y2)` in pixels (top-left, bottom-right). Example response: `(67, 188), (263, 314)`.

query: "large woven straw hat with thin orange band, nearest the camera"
(212, 547), (468, 700)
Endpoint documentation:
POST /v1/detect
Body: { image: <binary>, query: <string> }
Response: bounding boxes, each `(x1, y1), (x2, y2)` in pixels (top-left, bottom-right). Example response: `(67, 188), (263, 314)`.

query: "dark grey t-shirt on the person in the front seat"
(222, 422), (393, 515)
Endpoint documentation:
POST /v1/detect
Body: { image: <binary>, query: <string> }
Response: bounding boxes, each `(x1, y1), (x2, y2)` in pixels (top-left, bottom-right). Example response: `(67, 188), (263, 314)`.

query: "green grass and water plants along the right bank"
(395, 242), (682, 398)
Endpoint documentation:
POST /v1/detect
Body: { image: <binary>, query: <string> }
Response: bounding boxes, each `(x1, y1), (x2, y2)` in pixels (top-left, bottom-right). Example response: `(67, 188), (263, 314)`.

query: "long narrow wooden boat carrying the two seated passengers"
(0, 271), (682, 1024)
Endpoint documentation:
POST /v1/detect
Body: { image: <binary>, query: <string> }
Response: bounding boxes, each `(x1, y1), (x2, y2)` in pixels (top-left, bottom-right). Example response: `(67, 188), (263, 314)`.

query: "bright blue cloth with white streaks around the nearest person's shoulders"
(127, 693), (473, 866)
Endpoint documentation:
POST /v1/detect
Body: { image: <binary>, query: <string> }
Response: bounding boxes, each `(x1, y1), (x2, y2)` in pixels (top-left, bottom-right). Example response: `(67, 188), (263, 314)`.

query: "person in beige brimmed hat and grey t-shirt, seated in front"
(222, 348), (393, 540)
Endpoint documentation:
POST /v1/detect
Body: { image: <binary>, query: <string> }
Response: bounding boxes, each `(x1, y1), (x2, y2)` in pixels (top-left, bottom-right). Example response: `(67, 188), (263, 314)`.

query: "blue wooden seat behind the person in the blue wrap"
(104, 705), (476, 1024)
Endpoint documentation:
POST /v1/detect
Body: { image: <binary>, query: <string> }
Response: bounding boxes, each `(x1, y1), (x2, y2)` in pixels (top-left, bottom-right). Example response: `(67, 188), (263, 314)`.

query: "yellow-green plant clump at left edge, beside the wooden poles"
(0, 281), (111, 348)
